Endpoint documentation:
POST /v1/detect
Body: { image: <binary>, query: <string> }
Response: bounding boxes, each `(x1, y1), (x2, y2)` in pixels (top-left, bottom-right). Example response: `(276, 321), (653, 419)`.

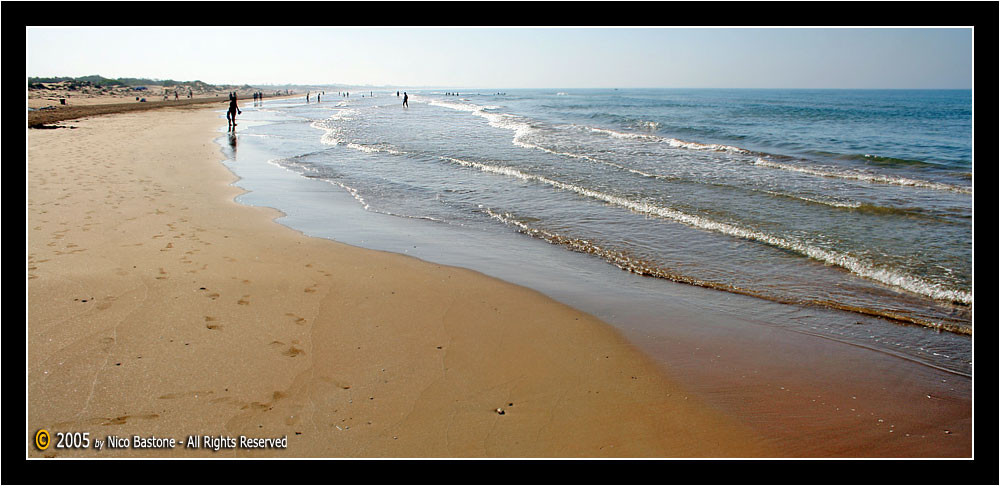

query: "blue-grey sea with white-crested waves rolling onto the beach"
(219, 87), (973, 376)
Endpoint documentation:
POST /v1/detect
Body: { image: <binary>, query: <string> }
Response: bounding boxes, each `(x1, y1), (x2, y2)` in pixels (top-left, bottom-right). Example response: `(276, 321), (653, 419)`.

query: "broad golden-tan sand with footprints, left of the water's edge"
(27, 104), (778, 457)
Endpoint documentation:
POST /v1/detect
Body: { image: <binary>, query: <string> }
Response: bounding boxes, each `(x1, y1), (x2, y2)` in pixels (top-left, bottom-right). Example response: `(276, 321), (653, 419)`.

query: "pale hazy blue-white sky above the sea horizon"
(26, 27), (972, 89)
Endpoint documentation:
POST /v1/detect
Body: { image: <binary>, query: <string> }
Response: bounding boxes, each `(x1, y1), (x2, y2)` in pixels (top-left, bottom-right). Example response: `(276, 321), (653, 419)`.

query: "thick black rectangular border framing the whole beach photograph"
(11, 0), (1000, 484)
